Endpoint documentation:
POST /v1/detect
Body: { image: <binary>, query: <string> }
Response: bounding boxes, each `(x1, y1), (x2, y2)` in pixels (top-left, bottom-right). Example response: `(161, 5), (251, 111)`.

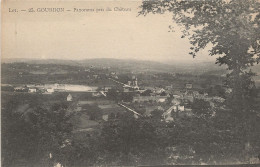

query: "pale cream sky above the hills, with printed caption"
(2, 0), (215, 62)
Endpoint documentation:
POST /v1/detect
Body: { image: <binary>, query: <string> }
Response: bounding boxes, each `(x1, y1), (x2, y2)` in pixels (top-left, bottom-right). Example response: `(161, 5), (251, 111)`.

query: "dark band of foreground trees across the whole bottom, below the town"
(2, 94), (260, 167)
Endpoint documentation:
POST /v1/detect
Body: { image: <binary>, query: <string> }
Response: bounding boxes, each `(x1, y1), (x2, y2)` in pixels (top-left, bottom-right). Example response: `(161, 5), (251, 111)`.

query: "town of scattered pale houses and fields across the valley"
(2, 63), (228, 124)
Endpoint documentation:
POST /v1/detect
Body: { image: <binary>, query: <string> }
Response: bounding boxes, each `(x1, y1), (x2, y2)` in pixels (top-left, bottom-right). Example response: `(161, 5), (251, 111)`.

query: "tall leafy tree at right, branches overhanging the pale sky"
(139, 0), (260, 111)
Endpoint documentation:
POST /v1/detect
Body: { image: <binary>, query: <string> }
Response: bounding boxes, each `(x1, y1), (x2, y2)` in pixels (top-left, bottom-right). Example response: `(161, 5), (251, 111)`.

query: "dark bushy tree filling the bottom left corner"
(2, 98), (72, 166)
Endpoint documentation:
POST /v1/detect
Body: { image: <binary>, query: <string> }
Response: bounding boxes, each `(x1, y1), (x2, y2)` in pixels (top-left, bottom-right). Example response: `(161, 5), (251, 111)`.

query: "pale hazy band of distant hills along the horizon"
(2, 58), (260, 75)
